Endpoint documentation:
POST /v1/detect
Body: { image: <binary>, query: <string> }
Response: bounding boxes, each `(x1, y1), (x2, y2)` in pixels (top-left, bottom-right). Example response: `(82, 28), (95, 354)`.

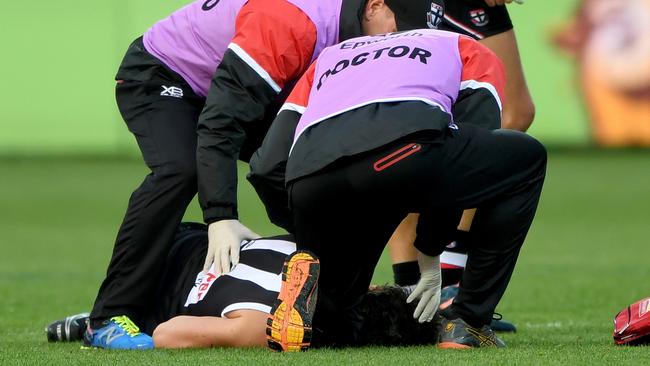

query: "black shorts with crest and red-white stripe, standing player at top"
(438, 0), (512, 40)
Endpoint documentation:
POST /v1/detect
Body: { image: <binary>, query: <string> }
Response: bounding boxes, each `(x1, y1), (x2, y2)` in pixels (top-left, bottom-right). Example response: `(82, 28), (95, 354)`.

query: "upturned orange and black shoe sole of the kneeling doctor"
(266, 251), (320, 352)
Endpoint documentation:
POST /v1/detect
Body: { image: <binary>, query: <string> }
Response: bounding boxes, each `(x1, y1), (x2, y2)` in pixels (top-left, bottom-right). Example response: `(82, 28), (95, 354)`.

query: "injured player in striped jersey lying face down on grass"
(46, 223), (437, 350)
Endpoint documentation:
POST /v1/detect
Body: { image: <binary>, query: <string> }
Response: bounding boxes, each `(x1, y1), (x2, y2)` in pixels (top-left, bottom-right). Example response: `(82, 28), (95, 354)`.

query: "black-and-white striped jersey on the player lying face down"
(181, 239), (296, 317)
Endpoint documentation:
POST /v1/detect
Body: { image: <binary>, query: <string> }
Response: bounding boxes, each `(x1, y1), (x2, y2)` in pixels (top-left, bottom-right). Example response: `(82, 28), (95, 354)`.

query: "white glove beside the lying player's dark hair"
(406, 252), (442, 323)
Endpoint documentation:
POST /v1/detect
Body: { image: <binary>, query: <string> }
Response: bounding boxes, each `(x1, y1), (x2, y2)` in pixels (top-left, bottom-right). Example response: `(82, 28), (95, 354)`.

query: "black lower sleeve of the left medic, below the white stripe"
(196, 50), (276, 223)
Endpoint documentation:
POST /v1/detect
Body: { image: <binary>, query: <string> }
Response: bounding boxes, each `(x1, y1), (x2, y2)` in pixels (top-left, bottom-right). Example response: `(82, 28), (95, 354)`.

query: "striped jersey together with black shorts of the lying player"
(141, 223), (296, 334)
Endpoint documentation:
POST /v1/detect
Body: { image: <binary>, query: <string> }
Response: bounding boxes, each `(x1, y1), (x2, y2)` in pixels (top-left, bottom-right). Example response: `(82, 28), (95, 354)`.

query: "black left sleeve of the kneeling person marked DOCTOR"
(247, 110), (301, 233)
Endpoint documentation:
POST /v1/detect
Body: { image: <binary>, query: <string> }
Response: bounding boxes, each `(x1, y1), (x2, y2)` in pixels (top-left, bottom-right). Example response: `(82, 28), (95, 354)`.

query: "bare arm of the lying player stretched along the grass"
(153, 310), (268, 348)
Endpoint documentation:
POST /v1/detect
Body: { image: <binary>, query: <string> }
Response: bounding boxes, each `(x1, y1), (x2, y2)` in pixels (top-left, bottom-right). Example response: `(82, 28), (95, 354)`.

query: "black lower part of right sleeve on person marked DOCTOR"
(451, 88), (501, 130)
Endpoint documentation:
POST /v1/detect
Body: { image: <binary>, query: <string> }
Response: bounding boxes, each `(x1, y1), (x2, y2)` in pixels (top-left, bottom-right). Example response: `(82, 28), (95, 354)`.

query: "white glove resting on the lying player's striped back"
(203, 220), (260, 276)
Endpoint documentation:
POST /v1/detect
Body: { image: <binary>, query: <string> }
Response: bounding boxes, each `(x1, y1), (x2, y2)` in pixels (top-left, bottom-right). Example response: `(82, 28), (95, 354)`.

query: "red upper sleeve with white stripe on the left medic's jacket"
(228, 0), (316, 92)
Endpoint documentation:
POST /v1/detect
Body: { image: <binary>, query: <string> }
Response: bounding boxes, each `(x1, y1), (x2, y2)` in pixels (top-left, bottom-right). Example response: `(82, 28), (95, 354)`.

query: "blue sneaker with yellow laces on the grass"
(84, 315), (154, 349)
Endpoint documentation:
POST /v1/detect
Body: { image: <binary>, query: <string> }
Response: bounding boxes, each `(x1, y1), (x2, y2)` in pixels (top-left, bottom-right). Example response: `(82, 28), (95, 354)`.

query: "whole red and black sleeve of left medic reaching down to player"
(197, 0), (316, 223)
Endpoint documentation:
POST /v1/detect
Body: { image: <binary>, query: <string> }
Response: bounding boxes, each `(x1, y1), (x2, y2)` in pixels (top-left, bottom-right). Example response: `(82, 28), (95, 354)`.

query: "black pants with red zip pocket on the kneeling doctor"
(289, 125), (546, 343)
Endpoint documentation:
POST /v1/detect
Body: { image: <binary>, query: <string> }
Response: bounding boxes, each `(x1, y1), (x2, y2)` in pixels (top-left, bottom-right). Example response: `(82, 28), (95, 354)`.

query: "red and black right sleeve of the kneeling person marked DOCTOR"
(452, 36), (506, 129)
